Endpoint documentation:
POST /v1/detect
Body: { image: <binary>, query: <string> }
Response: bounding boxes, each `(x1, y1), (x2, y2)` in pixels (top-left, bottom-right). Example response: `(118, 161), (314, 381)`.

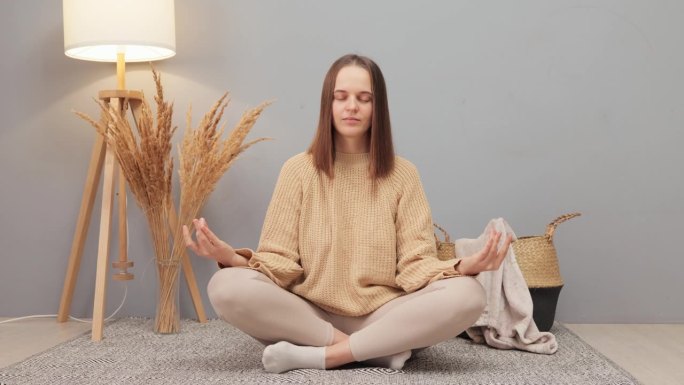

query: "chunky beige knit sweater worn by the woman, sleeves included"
(236, 153), (459, 316)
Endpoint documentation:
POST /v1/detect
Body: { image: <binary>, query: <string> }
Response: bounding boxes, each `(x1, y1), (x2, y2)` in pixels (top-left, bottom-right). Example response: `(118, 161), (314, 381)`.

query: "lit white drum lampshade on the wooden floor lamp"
(62, 0), (176, 62)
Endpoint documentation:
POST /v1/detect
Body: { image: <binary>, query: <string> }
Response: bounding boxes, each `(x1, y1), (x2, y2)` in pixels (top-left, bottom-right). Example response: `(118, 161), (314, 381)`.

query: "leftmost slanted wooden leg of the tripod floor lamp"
(57, 135), (105, 322)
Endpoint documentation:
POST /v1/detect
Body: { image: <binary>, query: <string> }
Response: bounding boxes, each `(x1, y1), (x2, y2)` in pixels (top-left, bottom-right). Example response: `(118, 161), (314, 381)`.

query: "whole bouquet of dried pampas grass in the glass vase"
(76, 68), (270, 333)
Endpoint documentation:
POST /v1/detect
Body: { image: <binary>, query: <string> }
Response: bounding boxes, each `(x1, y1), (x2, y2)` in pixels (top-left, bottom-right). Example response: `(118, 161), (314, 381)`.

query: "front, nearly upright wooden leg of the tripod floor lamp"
(92, 145), (116, 341)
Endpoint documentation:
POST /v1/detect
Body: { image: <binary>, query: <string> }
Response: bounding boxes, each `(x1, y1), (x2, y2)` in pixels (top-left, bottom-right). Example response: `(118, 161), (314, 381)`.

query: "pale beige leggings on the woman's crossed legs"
(207, 268), (486, 361)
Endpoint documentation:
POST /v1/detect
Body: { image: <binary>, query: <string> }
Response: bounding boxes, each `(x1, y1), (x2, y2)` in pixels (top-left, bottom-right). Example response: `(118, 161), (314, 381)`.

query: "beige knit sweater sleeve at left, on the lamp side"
(240, 157), (304, 288)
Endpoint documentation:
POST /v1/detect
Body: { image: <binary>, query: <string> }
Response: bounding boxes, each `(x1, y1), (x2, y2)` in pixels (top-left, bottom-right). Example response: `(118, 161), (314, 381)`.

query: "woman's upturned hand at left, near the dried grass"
(183, 218), (244, 266)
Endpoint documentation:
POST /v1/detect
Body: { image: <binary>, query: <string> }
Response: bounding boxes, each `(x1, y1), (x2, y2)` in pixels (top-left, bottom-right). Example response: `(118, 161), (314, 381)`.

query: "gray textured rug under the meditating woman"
(0, 318), (638, 385)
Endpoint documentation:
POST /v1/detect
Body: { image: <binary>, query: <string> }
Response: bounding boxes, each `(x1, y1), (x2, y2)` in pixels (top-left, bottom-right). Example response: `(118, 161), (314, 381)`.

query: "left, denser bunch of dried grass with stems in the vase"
(77, 68), (180, 333)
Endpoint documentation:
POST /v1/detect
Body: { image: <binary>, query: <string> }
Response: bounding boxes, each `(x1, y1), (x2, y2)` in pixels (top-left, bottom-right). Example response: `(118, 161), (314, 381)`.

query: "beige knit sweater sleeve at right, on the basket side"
(396, 165), (460, 293)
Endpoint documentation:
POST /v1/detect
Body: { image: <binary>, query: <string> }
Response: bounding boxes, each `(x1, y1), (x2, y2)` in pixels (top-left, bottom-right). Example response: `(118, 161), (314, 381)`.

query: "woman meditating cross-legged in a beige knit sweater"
(183, 55), (511, 373)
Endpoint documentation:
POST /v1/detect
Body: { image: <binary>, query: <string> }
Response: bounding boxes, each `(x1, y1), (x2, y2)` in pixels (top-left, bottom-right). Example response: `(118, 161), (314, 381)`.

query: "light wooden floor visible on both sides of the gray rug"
(0, 318), (684, 385)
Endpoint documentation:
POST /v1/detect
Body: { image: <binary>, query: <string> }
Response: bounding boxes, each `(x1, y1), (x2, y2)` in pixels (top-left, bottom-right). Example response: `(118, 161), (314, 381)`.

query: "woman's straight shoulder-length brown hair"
(308, 54), (394, 181)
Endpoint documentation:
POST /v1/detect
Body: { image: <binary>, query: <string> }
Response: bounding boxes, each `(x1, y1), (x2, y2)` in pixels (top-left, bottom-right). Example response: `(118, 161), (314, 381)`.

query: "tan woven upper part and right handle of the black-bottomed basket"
(512, 213), (581, 288)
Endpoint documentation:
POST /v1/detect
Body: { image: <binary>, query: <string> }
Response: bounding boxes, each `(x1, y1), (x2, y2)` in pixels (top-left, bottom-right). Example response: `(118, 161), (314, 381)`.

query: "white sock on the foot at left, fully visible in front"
(261, 341), (325, 373)
